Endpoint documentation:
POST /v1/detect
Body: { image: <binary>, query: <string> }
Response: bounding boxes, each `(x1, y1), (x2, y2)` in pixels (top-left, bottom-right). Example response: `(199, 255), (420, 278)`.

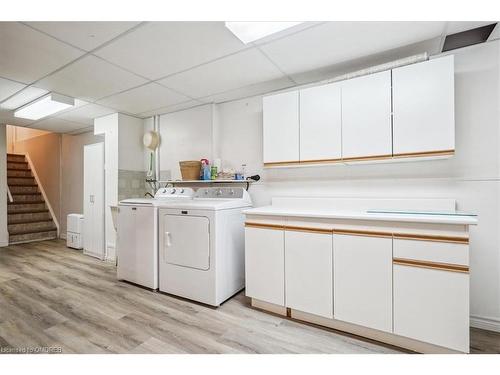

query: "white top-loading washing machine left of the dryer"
(117, 188), (194, 289)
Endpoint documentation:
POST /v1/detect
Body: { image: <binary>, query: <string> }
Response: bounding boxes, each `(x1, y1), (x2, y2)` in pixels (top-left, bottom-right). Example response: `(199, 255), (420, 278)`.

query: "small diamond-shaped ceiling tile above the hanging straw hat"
(99, 82), (190, 114)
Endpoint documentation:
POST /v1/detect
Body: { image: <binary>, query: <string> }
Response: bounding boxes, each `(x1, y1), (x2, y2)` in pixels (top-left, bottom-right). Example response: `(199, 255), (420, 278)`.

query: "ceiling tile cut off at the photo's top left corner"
(0, 22), (84, 83)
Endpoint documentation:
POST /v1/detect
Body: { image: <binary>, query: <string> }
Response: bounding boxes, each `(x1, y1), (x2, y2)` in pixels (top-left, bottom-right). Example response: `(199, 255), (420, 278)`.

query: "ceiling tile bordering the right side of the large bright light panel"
(259, 21), (445, 75)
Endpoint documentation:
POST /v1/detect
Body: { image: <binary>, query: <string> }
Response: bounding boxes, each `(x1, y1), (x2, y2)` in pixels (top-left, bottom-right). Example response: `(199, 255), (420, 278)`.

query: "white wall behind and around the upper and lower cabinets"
(216, 41), (500, 329)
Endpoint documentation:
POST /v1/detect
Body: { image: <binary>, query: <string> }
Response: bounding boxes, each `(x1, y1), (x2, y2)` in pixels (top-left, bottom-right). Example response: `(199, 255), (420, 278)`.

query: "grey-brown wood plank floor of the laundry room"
(0, 240), (500, 353)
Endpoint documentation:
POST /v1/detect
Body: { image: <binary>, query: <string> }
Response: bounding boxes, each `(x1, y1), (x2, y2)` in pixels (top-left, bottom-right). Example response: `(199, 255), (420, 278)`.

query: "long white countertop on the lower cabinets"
(243, 205), (478, 225)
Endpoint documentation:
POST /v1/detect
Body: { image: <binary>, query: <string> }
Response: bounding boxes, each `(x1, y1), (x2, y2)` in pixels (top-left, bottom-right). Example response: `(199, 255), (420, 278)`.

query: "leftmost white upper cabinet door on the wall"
(263, 91), (299, 163)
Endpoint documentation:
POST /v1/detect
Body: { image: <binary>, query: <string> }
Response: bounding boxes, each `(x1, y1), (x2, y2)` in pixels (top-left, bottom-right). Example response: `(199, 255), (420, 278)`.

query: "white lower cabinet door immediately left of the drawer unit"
(333, 234), (392, 332)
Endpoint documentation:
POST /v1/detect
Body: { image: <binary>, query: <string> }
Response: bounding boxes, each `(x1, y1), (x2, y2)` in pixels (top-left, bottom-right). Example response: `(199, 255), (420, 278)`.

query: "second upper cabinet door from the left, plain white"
(300, 83), (342, 161)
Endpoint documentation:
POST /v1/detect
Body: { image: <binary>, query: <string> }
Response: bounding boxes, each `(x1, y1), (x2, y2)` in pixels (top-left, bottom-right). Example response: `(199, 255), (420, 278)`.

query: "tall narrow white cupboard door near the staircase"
(83, 142), (105, 259)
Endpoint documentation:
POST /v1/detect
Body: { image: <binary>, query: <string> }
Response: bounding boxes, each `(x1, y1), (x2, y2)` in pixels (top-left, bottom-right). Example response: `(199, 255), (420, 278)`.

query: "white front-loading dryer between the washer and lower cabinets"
(158, 187), (252, 306)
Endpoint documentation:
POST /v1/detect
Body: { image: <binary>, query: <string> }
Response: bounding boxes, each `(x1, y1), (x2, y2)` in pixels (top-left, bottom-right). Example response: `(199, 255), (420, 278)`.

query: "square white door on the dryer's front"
(160, 215), (210, 270)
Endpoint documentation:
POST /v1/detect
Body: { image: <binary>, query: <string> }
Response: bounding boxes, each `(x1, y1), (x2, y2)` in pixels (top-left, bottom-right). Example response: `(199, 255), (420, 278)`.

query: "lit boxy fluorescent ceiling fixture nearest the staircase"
(14, 92), (75, 120)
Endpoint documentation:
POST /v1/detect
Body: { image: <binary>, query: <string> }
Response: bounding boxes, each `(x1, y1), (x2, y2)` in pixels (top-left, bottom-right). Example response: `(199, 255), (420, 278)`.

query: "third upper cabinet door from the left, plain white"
(342, 71), (392, 158)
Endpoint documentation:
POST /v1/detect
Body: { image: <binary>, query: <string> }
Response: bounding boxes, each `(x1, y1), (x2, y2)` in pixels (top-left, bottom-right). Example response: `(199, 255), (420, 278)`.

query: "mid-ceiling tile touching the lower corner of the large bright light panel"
(158, 48), (284, 98)
